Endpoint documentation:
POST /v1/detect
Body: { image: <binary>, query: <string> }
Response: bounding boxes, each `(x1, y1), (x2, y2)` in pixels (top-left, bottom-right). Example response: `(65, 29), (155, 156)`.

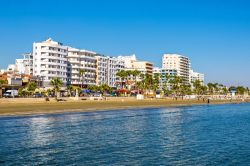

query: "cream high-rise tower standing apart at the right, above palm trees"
(162, 54), (190, 83)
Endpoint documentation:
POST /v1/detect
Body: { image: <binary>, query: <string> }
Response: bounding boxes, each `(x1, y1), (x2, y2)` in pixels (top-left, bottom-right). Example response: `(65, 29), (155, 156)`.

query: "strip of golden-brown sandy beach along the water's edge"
(0, 98), (250, 117)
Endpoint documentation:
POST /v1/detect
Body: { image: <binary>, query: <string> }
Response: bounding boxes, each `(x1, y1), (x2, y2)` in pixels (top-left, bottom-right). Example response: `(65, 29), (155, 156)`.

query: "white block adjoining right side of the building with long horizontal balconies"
(96, 55), (124, 87)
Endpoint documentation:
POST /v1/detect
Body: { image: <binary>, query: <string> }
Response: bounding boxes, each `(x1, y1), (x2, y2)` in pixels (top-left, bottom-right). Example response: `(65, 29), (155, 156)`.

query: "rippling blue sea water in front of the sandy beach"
(0, 104), (250, 165)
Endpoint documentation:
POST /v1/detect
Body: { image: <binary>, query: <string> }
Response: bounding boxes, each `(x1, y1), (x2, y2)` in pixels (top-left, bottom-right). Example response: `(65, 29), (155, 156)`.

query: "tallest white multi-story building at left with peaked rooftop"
(33, 38), (68, 87)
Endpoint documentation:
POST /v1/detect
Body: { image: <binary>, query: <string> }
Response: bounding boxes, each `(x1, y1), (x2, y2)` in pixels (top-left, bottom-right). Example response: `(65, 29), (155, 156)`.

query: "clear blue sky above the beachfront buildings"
(0, 0), (250, 86)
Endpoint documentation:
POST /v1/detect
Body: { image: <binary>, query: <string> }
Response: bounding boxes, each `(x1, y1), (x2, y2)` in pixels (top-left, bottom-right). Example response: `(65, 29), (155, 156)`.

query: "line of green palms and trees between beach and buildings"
(16, 70), (249, 96)
